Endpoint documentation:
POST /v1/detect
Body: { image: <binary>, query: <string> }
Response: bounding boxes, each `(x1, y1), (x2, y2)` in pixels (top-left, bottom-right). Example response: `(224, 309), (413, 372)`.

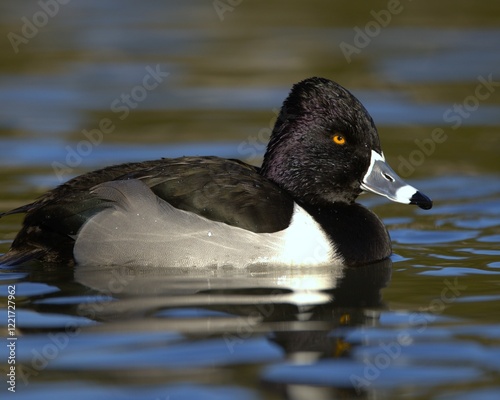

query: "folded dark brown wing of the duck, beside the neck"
(127, 157), (293, 232)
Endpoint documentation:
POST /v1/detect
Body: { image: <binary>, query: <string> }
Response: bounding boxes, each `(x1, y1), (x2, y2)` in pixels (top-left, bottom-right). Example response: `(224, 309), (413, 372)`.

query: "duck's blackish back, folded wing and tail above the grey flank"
(0, 157), (293, 264)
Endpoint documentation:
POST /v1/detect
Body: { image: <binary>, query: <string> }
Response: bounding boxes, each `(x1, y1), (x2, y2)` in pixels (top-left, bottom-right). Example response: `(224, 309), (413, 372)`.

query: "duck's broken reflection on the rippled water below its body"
(70, 259), (392, 398)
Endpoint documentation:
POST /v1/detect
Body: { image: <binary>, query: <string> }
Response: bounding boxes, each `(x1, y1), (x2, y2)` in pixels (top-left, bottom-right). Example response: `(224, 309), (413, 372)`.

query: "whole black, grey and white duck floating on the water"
(0, 78), (432, 267)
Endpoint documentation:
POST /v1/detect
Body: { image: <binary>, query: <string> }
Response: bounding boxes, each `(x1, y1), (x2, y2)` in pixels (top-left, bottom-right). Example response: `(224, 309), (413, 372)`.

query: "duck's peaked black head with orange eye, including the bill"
(262, 78), (432, 209)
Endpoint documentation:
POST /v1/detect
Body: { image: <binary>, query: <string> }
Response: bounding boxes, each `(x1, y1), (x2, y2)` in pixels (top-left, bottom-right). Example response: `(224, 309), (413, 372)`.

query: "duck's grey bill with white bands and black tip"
(361, 150), (432, 210)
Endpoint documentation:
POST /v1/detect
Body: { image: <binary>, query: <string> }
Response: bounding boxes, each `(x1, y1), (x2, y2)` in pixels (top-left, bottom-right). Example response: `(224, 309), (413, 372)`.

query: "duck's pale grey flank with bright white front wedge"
(74, 179), (341, 268)
